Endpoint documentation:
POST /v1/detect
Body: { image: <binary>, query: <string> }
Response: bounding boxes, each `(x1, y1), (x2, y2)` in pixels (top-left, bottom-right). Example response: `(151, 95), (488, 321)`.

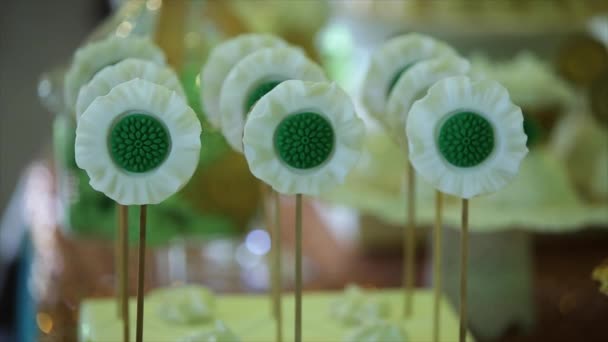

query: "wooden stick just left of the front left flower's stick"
(116, 204), (130, 342)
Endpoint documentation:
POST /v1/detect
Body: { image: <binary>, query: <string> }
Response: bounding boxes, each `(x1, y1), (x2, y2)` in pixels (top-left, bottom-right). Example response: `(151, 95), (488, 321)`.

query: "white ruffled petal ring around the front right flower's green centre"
(406, 76), (528, 198)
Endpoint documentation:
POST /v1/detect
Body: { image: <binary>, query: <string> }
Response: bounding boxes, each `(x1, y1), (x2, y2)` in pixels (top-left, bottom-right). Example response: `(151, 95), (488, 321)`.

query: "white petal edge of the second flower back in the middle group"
(220, 47), (326, 152)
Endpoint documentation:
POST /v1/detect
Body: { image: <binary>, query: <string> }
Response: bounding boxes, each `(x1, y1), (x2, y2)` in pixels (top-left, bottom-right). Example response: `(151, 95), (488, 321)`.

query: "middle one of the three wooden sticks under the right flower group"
(433, 190), (443, 342)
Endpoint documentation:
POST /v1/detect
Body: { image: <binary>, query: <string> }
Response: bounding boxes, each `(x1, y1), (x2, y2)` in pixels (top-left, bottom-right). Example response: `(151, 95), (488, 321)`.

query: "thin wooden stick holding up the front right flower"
(459, 198), (469, 342)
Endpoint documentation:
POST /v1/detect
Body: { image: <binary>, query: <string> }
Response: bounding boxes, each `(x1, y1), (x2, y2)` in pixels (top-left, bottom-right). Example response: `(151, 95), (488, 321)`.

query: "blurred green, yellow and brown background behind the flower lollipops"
(0, 0), (608, 341)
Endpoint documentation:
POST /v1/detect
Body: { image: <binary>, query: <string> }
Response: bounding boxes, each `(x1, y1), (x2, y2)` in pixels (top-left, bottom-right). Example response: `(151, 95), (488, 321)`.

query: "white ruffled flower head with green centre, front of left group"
(75, 79), (201, 205)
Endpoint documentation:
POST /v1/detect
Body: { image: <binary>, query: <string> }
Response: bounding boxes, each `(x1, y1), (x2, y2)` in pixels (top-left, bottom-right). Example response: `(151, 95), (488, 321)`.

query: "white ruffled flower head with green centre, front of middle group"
(243, 80), (365, 195)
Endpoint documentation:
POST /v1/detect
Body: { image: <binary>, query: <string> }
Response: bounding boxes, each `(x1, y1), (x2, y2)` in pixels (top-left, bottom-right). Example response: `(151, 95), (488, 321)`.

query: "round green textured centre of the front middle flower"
(274, 112), (335, 170)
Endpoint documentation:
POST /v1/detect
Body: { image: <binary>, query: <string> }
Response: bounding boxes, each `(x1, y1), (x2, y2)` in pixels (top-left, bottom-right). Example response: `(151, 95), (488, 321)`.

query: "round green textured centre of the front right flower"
(438, 111), (495, 168)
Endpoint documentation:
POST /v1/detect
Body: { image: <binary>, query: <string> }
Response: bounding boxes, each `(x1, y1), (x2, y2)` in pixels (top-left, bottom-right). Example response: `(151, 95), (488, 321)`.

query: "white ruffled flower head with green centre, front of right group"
(406, 76), (528, 199)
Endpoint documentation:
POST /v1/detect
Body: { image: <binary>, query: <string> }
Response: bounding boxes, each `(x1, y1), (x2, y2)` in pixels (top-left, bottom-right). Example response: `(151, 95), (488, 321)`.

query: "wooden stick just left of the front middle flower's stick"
(272, 190), (283, 342)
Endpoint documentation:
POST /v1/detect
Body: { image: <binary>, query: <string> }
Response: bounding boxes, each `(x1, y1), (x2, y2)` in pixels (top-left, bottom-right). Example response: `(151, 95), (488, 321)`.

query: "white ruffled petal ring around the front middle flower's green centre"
(243, 80), (365, 196)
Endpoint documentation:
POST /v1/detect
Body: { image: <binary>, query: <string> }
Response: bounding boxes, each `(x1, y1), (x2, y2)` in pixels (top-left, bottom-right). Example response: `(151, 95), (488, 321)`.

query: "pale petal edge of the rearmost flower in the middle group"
(201, 33), (287, 128)
